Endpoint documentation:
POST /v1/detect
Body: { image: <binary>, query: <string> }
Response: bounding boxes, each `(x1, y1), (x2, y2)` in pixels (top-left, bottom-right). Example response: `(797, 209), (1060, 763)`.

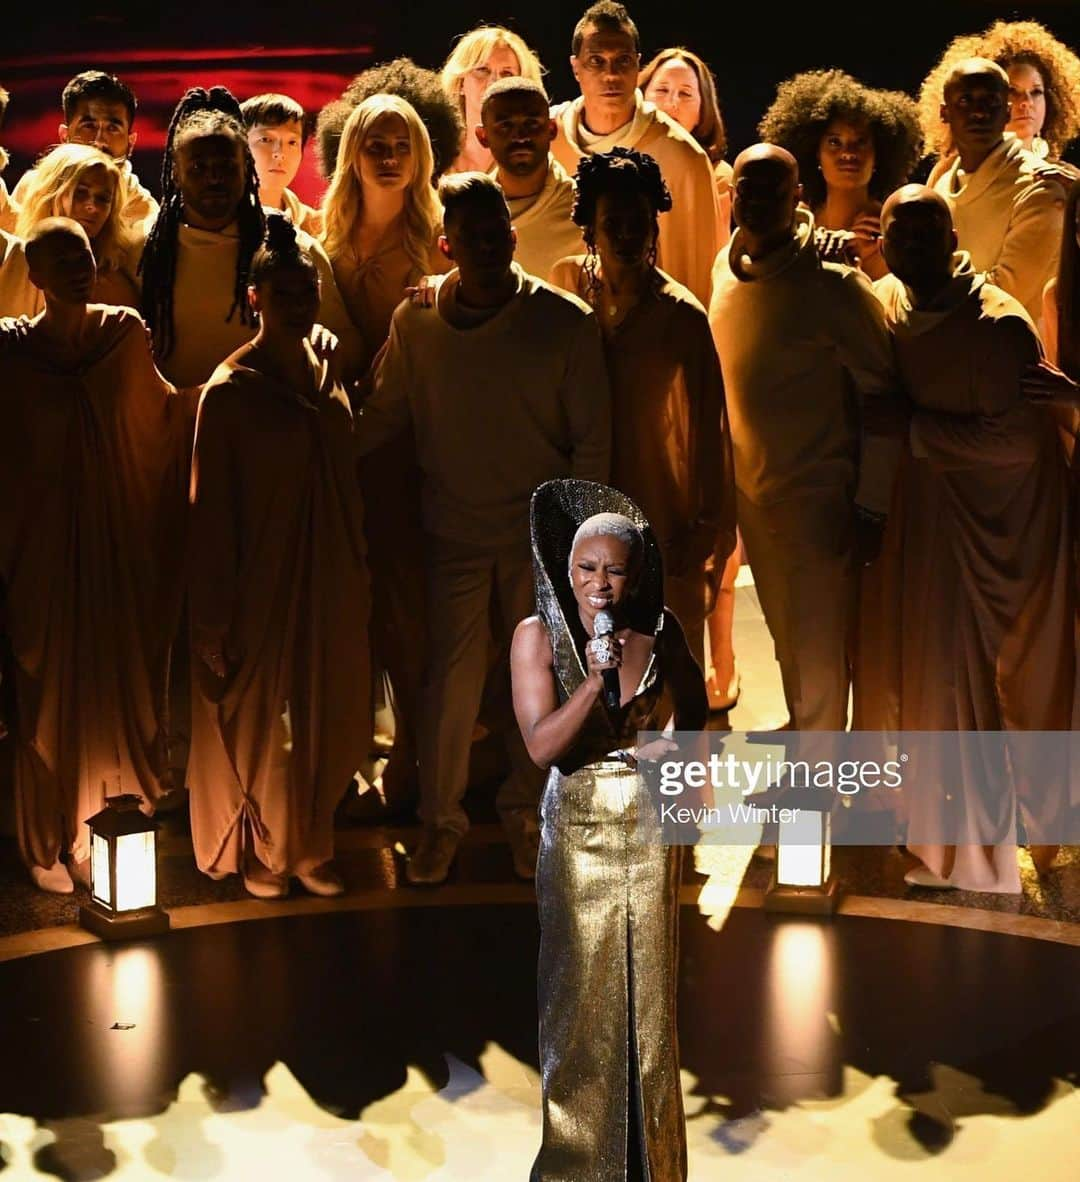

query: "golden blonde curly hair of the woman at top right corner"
(919, 20), (1080, 156)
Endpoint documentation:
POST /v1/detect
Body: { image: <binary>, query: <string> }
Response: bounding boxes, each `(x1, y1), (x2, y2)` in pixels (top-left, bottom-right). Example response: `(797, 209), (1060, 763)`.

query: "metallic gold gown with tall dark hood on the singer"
(532, 481), (687, 1182)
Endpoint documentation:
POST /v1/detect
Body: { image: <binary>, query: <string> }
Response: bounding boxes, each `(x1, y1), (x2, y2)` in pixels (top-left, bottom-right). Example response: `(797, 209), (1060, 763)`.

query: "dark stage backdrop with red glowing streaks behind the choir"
(0, 0), (1080, 200)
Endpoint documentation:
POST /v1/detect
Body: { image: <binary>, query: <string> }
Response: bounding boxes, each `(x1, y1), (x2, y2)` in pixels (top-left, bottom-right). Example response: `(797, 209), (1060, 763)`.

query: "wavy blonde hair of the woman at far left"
(15, 144), (135, 271)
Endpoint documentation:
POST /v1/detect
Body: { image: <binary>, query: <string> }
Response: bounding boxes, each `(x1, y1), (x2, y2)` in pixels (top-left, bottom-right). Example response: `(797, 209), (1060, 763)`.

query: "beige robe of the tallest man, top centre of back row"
(552, 91), (721, 307)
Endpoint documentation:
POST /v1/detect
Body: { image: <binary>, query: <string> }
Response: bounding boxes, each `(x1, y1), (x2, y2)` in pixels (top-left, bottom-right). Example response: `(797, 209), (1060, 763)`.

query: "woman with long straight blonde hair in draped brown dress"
(323, 95), (450, 813)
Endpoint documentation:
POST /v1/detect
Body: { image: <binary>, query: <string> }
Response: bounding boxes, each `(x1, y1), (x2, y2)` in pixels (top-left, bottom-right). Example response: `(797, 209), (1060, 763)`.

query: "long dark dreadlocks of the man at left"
(139, 86), (265, 357)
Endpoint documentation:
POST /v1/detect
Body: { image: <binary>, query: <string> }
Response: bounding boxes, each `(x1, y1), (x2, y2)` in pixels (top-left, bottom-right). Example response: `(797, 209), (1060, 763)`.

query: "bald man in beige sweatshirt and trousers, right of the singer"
(709, 144), (899, 730)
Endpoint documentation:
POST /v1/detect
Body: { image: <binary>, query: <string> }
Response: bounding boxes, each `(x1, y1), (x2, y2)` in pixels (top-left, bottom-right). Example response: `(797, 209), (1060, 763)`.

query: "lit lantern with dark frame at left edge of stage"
(79, 793), (169, 940)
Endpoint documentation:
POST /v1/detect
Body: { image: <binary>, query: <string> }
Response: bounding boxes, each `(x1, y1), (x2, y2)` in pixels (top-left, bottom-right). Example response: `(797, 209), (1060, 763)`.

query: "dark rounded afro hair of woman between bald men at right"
(757, 70), (923, 209)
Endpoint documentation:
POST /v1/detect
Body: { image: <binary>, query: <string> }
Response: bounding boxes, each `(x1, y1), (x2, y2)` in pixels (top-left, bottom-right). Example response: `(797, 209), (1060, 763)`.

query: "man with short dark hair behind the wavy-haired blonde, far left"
(12, 70), (157, 226)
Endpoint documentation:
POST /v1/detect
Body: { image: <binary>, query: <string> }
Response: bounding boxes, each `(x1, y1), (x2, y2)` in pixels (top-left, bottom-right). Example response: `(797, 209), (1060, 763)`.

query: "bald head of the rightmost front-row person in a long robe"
(881, 184), (956, 304)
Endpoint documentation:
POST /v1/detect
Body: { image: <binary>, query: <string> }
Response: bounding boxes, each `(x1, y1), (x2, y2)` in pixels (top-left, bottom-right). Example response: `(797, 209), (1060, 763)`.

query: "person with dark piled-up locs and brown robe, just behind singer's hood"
(552, 148), (735, 667)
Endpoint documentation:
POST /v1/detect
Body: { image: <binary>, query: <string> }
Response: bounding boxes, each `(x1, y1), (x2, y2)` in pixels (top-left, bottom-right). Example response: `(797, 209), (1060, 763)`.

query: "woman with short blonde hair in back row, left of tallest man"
(440, 25), (542, 173)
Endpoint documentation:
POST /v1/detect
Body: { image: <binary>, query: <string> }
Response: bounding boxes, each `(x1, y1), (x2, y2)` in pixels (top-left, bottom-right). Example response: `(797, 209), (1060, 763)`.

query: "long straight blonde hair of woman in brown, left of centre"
(323, 95), (442, 274)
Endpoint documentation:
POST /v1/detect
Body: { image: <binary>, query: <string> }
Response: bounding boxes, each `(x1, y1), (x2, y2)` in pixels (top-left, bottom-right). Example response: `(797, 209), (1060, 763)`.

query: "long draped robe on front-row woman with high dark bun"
(188, 345), (371, 877)
